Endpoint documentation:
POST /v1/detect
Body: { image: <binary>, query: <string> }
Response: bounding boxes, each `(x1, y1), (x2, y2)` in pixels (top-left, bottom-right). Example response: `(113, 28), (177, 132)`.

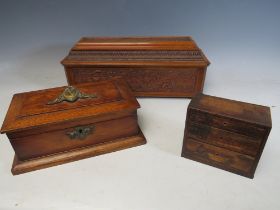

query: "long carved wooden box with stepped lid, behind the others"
(61, 37), (209, 97)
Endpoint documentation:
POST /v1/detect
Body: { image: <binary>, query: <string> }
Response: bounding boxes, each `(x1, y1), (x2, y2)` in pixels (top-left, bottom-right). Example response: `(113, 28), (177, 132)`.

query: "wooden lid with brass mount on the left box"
(1, 79), (140, 133)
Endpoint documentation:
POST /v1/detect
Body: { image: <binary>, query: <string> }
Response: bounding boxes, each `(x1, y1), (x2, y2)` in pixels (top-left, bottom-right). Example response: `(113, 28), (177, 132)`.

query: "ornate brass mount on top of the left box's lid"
(47, 86), (97, 105)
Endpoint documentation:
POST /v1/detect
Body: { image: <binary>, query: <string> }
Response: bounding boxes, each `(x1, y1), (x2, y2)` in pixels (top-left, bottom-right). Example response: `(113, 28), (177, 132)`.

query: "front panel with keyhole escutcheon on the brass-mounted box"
(10, 115), (138, 160)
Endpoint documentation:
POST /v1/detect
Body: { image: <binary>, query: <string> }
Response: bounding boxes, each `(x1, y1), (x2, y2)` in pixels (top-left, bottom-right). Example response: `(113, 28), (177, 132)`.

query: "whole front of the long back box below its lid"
(66, 66), (205, 97)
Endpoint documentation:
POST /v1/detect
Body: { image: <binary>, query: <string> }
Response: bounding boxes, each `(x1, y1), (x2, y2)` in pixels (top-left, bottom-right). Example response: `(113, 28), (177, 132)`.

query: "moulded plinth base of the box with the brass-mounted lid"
(11, 129), (146, 175)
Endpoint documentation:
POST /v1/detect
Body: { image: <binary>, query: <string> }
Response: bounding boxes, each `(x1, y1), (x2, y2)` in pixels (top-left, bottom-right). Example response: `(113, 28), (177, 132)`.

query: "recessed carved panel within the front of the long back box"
(72, 67), (197, 93)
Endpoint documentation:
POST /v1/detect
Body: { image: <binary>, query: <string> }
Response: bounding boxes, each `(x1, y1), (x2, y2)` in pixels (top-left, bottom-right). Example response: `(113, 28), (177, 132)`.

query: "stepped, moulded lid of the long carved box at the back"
(61, 36), (210, 66)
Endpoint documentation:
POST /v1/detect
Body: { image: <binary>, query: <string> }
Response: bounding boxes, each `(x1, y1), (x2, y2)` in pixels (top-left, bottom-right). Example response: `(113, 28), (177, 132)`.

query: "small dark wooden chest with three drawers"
(182, 94), (272, 178)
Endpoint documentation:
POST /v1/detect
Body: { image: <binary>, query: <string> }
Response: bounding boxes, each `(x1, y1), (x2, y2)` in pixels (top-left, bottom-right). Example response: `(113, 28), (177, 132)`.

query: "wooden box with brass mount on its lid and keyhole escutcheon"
(1, 79), (146, 175)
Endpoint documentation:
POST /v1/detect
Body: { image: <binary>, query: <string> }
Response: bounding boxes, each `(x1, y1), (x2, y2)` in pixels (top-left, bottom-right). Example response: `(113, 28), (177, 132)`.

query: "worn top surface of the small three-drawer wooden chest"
(189, 93), (272, 127)
